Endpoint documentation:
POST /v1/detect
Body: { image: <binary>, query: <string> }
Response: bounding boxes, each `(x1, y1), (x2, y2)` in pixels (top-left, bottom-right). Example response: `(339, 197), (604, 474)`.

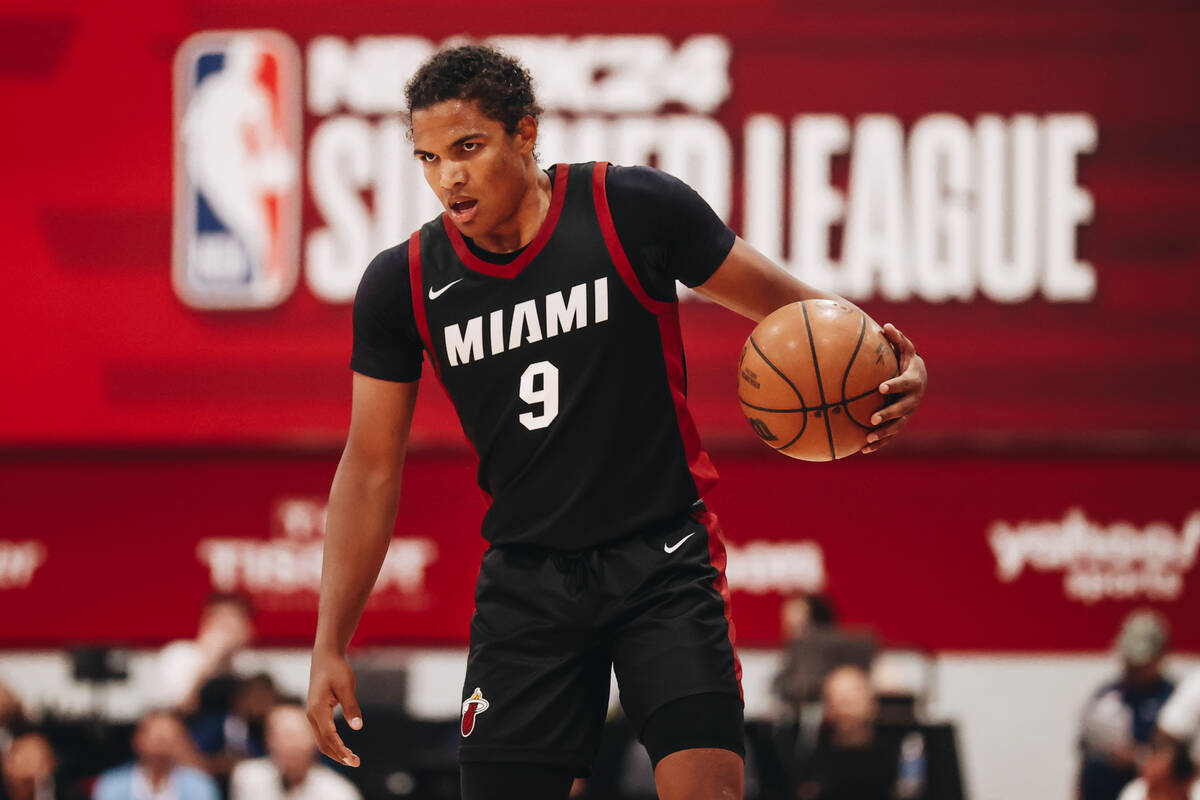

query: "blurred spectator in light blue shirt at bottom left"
(91, 711), (221, 800)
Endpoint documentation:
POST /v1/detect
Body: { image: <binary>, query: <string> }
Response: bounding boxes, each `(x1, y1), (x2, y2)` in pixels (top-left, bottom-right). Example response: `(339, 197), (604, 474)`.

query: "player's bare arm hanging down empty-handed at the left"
(308, 373), (418, 766)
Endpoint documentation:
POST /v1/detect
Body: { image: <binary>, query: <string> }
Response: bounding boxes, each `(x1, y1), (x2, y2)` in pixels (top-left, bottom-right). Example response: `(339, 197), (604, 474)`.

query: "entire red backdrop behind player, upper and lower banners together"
(0, 0), (1200, 650)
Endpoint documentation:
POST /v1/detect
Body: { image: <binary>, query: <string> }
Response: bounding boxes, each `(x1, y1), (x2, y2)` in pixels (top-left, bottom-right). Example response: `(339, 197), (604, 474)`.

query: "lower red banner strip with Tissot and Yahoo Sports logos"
(0, 456), (1200, 651)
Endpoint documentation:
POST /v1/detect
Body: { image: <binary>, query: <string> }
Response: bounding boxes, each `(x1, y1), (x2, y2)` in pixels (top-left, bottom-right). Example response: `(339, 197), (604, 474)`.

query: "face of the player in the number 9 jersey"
(413, 100), (536, 239)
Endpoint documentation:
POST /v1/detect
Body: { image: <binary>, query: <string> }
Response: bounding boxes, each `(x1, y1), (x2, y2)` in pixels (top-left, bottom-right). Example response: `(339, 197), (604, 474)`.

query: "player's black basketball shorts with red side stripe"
(458, 504), (742, 775)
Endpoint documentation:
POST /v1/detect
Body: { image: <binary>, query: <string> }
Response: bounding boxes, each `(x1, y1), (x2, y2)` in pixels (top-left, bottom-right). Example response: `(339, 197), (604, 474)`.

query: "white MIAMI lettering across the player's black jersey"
(445, 278), (608, 367)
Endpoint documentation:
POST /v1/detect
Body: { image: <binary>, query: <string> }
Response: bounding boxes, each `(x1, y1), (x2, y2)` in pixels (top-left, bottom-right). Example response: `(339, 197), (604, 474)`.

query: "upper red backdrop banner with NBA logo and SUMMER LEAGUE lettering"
(0, 0), (1200, 446)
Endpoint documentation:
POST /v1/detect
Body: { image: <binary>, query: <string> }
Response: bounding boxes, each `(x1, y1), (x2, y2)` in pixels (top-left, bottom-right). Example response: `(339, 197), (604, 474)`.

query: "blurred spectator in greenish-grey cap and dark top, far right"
(1079, 610), (1175, 800)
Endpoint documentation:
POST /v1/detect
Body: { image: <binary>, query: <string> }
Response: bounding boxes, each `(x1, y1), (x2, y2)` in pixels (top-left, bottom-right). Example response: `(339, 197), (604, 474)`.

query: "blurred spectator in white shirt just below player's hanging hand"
(229, 703), (361, 800)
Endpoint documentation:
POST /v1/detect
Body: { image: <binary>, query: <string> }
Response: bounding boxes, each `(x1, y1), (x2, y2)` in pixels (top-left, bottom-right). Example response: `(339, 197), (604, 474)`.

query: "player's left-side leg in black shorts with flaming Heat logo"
(458, 548), (610, 800)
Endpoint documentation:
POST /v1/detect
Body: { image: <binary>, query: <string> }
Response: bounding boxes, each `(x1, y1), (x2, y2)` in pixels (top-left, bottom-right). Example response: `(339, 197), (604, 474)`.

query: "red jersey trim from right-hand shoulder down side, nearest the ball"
(592, 161), (716, 497)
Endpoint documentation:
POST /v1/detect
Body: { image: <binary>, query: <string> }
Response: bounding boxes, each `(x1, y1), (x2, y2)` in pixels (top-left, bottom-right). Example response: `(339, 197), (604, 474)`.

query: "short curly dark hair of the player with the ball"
(404, 44), (541, 133)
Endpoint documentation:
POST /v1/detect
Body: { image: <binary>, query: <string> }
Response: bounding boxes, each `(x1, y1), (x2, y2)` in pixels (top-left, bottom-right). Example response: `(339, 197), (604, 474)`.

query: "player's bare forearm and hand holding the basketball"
(696, 236), (928, 453)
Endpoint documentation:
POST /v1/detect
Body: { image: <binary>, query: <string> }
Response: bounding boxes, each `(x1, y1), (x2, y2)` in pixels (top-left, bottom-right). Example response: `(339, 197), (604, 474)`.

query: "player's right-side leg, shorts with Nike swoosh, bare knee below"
(606, 509), (745, 800)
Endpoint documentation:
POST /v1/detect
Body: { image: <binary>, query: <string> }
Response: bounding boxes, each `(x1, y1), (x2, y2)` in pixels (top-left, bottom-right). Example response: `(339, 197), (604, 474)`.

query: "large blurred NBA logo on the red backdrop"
(172, 30), (300, 308)
